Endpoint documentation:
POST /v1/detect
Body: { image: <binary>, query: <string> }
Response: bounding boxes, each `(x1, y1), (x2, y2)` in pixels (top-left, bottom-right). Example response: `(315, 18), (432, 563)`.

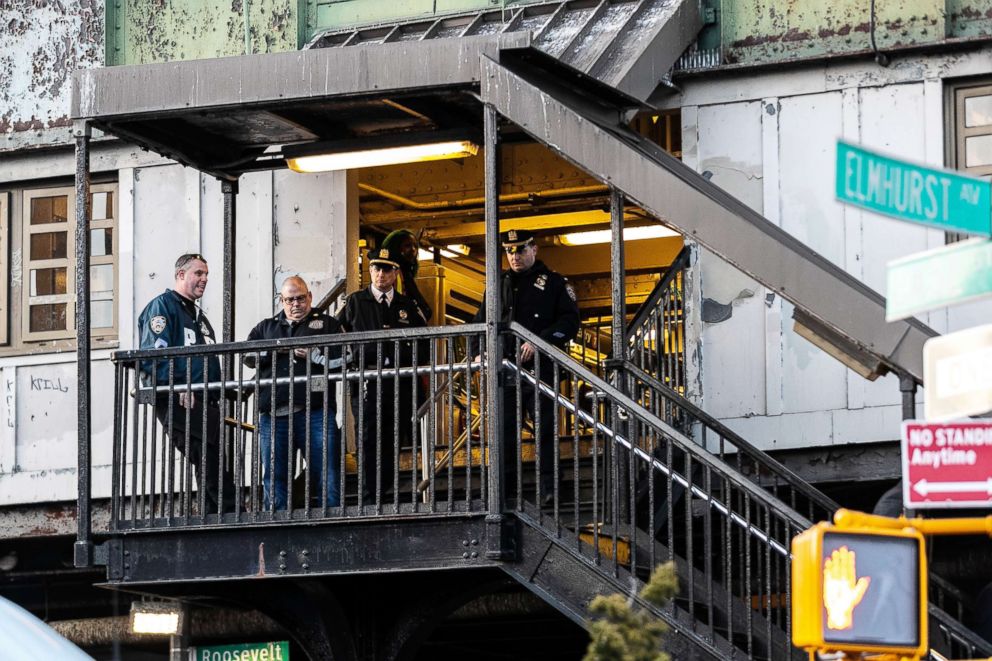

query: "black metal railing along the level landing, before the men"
(112, 324), (486, 529)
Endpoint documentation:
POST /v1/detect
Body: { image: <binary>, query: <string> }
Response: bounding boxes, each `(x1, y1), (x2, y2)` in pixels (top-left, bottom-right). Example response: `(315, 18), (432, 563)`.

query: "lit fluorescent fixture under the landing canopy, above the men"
(283, 131), (479, 173)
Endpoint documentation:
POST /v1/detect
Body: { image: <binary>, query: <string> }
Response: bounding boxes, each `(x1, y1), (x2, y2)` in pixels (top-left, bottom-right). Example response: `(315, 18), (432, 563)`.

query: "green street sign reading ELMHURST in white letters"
(836, 141), (992, 236)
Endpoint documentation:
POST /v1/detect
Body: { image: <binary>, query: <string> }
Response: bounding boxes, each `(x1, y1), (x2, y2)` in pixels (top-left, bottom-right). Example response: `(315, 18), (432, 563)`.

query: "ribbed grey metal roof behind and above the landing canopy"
(307, 0), (703, 102)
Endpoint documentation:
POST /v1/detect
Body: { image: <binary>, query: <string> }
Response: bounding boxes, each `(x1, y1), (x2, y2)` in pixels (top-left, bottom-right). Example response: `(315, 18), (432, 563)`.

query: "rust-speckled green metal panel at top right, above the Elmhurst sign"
(720, 0), (948, 64)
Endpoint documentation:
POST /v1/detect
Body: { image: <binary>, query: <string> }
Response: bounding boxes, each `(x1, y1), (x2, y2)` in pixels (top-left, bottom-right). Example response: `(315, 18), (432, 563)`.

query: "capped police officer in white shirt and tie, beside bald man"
(338, 248), (427, 500)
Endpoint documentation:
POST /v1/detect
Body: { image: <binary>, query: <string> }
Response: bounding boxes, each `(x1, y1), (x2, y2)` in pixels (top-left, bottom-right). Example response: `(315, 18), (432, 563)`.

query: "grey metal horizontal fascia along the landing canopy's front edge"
(72, 33), (530, 120)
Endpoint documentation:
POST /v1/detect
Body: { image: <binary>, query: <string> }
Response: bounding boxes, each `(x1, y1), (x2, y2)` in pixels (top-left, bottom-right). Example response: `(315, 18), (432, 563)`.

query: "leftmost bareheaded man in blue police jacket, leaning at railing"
(138, 253), (235, 514)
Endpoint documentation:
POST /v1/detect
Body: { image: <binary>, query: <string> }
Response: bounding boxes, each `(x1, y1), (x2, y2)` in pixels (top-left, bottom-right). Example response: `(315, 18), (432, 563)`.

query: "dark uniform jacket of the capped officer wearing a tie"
(338, 287), (428, 367)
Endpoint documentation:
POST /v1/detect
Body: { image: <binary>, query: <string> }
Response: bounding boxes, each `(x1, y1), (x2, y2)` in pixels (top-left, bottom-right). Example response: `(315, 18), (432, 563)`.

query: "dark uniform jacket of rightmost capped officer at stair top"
(472, 260), (579, 354)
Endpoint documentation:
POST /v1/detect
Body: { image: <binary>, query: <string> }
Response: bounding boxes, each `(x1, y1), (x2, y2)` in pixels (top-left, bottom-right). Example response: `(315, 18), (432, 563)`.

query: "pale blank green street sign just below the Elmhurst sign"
(885, 239), (992, 321)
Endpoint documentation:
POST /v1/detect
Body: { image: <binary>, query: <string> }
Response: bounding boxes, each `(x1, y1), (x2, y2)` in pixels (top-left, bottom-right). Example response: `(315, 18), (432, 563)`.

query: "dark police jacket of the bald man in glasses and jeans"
(244, 310), (341, 413)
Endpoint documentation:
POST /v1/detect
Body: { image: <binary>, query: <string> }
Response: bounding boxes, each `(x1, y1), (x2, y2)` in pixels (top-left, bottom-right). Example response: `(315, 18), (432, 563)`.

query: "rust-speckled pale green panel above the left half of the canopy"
(107, 0), (301, 64)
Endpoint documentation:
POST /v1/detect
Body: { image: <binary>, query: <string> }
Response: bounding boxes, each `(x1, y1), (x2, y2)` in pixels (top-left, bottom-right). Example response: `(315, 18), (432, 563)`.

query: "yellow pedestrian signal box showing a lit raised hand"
(792, 523), (927, 657)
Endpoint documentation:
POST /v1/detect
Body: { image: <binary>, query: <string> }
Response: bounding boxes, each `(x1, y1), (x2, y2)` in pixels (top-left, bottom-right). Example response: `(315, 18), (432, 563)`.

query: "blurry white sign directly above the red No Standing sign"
(923, 325), (992, 421)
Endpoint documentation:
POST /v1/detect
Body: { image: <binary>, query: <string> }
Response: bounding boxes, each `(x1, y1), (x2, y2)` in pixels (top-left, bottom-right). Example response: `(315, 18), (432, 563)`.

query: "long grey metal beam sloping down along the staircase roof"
(482, 55), (937, 383)
